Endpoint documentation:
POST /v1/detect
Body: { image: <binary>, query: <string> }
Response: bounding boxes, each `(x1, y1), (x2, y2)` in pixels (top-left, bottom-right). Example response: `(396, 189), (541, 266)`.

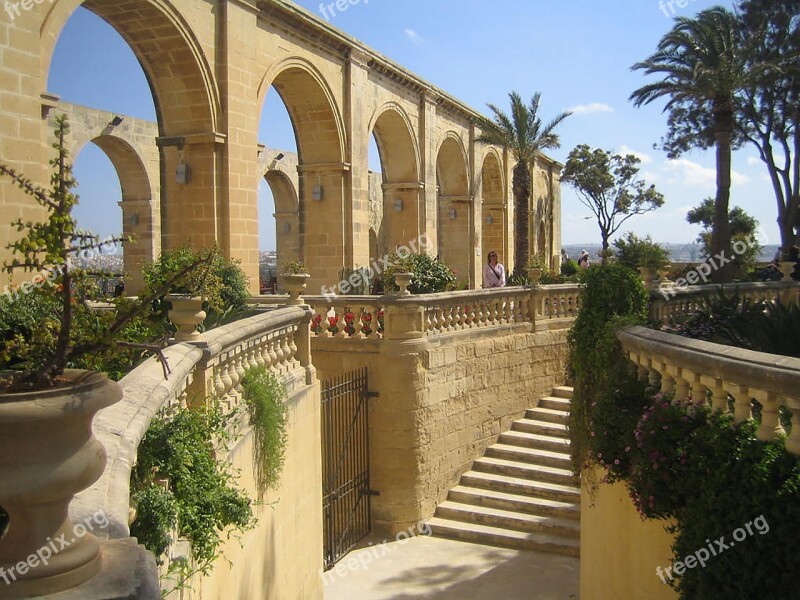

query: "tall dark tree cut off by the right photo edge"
(737, 0), (800, 260)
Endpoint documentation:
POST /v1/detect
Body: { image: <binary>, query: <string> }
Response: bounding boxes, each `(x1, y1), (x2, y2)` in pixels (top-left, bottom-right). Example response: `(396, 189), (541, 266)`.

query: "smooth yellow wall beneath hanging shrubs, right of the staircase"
(581, 470), (678, 600)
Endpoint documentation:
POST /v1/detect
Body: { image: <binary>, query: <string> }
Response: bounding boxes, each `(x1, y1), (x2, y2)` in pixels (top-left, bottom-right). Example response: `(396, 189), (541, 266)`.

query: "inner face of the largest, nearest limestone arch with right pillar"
(44, 0), (222, 252)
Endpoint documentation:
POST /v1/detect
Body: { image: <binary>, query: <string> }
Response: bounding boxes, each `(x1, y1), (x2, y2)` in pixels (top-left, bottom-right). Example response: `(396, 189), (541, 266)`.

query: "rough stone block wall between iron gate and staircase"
(312, 325), (567, 535)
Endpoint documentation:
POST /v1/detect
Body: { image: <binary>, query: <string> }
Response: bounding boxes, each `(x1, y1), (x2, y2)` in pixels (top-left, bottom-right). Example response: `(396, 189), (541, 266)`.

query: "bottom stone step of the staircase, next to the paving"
(428, 517), (580, 556)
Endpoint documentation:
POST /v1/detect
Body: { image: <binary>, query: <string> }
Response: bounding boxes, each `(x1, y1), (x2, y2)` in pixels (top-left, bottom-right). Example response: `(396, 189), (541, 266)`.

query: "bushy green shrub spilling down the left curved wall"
(131, 402), (255, 571)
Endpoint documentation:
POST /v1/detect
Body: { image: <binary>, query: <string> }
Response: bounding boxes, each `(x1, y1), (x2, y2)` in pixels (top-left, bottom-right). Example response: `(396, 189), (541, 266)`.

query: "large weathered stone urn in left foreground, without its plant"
(0, 370), (122, 598)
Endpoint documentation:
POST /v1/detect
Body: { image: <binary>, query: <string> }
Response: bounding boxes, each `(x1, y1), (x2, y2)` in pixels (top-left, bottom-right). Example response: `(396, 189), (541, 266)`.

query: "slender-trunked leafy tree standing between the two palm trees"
(561, 144), (664, 263)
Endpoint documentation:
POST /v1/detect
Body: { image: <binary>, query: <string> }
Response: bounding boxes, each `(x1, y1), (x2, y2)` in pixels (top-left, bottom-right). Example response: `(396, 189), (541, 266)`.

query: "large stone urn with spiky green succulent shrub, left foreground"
(0, 116), (206, 596)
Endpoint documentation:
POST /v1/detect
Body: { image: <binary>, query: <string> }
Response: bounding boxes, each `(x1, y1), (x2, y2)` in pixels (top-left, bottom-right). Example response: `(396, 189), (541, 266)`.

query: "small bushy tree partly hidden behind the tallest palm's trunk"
(686, 198), (761, 277)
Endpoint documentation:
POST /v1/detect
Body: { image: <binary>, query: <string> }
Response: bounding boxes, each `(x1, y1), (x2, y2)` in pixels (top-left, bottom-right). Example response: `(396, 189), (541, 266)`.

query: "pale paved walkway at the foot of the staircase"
(323, 536), (579, 600)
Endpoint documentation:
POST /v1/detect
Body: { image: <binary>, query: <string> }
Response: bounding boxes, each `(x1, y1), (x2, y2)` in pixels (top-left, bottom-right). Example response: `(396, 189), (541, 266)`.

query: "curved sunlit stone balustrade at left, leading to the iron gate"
(65, 306), (316, 598)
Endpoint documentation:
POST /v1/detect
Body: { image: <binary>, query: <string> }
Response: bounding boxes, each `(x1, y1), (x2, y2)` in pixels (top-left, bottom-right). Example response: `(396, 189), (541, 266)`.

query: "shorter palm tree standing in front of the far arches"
(476, 92), (571, 277)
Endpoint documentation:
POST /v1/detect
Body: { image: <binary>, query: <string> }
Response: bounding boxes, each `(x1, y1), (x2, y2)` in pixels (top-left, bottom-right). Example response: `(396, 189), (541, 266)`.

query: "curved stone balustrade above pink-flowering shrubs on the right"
(619, 327), (800, 455)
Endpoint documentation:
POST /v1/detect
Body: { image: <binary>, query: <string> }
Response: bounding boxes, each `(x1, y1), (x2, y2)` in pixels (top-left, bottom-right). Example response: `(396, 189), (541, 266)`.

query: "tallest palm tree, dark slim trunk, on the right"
(630, 7), (746, 282)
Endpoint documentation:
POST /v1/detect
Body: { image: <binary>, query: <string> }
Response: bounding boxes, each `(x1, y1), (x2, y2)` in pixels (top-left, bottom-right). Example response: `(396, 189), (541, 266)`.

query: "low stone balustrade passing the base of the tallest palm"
(650, 281), (800, 323)
